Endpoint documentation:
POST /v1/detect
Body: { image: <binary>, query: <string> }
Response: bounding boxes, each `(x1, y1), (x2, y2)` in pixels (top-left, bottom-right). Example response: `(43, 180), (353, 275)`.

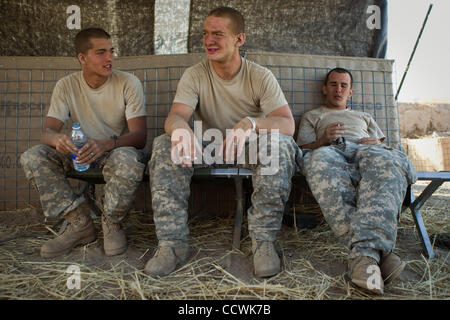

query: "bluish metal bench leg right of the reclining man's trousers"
(406, 186), (436, 259)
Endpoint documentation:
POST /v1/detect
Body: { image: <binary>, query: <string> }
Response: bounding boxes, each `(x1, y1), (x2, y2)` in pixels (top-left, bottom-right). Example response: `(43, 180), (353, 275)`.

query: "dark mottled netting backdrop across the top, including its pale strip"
(0, 0), (387, 57)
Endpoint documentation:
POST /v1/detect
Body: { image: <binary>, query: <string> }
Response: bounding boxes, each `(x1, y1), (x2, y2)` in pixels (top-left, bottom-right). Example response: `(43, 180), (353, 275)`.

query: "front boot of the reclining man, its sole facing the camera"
(348, 256), (384, 295)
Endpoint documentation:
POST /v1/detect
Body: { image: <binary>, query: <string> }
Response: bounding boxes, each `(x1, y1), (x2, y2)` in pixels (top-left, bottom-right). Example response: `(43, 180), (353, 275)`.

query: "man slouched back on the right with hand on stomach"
(297, 68), (417, 294)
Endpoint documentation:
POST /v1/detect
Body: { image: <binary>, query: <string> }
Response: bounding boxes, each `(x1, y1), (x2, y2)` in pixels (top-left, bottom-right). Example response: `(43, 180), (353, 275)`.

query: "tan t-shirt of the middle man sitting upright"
(174, 59), (287, 135)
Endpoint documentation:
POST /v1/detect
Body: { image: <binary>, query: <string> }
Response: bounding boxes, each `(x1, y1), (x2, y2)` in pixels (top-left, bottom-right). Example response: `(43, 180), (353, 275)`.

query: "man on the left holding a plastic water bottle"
(21, 28), (148, 258)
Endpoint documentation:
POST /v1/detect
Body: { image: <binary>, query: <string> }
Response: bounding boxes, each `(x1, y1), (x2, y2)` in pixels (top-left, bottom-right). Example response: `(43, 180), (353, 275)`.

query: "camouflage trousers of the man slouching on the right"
(302, 142), (417, 261)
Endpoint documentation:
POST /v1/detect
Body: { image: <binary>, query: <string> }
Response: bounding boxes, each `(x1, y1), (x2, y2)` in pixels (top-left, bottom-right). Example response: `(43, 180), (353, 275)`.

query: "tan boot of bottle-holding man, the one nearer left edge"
(41, 201), (96, 258)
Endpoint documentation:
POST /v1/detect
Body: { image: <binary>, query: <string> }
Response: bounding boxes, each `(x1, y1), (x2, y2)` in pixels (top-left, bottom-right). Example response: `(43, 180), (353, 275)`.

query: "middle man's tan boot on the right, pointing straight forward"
(252, 239), (281, 278)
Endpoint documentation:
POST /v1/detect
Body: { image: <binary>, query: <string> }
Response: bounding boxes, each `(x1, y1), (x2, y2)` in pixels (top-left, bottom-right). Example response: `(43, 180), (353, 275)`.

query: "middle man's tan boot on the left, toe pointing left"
(144, 246), (189, 277)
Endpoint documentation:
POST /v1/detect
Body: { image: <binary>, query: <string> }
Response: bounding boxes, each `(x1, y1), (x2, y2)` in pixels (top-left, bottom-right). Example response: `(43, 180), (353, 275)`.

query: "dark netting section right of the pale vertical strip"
(188, 0), (384, 57)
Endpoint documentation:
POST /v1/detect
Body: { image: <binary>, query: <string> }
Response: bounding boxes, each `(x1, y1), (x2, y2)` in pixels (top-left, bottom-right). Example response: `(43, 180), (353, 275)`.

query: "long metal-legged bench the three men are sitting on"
(67, 168), (450, 259)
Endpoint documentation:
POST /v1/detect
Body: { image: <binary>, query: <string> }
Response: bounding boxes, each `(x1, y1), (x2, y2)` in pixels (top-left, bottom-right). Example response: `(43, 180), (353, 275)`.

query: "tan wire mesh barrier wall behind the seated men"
(0, 54), (400, 211)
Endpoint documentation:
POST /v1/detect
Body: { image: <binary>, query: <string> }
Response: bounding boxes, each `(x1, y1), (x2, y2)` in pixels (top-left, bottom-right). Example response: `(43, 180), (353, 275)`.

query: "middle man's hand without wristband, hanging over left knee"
(171, 128), (202, 168)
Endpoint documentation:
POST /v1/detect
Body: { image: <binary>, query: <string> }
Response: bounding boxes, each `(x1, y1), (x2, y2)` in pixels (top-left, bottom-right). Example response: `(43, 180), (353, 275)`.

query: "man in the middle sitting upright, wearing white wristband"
(145, 7), (299, 277)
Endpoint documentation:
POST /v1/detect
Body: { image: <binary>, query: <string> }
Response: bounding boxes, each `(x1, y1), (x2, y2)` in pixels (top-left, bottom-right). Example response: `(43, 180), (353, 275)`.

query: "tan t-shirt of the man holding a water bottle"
(47, 70), (146, 139)
